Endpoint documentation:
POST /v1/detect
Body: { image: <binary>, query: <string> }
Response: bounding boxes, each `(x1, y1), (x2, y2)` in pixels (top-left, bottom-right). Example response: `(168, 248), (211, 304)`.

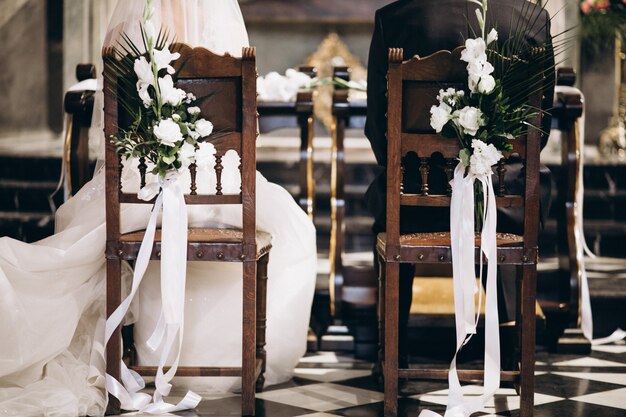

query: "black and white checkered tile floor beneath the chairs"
(112, 342), (626, 417)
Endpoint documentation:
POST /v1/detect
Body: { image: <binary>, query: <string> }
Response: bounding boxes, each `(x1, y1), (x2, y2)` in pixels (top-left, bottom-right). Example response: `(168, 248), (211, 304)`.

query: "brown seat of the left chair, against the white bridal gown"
(119, 228), (272, 262)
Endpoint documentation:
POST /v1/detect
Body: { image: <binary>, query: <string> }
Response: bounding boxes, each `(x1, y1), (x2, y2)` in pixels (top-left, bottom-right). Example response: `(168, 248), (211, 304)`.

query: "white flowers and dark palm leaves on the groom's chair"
(430, 0), (552, 231)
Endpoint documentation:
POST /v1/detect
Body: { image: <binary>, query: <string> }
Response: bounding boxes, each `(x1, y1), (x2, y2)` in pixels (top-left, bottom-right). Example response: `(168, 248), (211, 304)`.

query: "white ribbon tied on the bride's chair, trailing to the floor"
(105, 173), (201, 414)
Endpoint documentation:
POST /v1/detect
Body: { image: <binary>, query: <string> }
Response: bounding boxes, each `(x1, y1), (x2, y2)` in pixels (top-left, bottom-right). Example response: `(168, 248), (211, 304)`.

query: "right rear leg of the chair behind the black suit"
(520, 265), (537, 417)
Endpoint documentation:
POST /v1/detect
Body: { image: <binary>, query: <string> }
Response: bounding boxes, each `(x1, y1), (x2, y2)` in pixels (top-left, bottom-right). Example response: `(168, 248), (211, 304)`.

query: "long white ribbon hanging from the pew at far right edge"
(555, 85), (626, 345)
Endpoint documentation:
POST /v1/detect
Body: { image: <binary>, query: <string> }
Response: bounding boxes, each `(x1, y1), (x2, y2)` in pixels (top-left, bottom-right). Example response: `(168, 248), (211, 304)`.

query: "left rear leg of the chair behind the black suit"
(383, 262), (400, 417)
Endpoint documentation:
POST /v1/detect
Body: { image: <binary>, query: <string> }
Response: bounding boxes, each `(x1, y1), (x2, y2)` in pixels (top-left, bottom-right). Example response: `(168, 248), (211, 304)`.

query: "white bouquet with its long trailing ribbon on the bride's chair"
(105, 0), (224, 413)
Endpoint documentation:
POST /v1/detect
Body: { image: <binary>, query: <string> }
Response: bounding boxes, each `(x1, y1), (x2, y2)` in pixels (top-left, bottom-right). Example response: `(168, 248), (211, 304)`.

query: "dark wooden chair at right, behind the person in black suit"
(377, 48), (541, 416)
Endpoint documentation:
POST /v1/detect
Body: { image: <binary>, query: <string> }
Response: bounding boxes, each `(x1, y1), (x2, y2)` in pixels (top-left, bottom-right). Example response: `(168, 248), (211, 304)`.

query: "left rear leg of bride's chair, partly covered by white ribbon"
(106, 258), (122, 414)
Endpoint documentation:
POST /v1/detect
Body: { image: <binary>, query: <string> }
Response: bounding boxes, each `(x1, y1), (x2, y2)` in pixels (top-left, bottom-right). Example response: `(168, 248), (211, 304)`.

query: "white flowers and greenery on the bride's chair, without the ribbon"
(106, 0), (215, 179)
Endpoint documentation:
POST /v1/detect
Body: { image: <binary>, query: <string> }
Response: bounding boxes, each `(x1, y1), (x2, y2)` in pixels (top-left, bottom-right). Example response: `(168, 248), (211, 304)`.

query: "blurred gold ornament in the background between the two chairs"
(305, 32), (367, 131)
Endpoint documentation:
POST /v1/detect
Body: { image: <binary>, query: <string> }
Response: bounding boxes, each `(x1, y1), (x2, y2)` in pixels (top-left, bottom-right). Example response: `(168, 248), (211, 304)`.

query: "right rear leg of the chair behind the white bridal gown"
(241, 260), (256, 416)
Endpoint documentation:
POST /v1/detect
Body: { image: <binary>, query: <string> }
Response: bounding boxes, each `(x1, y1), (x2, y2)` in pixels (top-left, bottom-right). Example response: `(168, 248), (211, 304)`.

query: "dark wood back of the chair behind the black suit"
(387, 48), (541, 258)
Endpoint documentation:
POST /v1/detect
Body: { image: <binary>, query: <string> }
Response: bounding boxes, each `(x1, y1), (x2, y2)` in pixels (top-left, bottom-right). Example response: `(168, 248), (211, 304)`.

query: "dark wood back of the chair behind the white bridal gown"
(104, 44), (257, 254)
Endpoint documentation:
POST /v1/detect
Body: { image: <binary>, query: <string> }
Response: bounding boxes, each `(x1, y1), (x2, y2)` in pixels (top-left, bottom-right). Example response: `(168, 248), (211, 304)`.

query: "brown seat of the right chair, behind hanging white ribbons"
(376, 232), (536, 264)
